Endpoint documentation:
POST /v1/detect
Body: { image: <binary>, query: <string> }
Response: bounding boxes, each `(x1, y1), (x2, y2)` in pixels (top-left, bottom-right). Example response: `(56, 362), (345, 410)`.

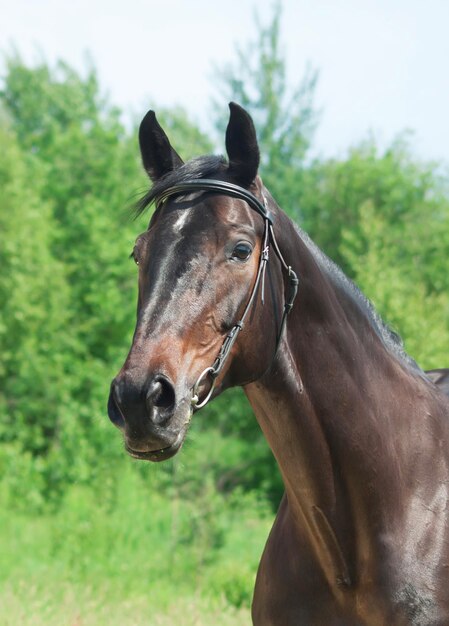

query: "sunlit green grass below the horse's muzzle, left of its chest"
(0, 462), (272, 626)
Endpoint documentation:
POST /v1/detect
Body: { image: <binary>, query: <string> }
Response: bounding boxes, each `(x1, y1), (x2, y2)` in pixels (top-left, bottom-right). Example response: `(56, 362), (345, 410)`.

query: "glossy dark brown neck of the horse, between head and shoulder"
(245, 202), (430, 582)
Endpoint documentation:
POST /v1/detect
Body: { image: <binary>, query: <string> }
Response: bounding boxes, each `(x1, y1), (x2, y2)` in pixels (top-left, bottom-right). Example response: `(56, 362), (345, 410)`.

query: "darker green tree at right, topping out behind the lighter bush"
(302, 136), (449, 291)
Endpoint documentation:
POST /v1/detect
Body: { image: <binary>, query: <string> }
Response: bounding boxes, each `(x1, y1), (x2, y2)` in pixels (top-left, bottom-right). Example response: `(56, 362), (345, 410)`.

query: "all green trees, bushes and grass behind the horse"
(0, 6), (449, 626)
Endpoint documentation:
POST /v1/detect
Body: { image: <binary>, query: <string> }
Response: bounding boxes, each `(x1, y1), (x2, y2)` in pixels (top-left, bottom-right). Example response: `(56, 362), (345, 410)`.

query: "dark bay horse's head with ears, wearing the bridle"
(108, 103), (283, 461)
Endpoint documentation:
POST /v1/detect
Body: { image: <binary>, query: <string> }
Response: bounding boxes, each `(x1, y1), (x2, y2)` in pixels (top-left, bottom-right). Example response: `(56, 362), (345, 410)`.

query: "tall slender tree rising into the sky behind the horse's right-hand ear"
(214, 3), (318, 219)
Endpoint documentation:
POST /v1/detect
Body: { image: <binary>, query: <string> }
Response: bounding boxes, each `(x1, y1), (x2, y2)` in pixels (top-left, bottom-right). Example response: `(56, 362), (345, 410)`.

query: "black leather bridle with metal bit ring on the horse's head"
(155, 178), (299, 410)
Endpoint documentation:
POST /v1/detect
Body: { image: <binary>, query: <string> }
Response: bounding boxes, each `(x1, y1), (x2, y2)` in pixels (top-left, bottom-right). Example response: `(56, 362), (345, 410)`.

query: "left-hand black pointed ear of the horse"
(139, 111), (183, 182)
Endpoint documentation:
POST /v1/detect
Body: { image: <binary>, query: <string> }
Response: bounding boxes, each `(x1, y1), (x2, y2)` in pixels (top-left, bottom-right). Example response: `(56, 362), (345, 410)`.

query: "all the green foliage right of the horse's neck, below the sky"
(302, 136), (449, 368)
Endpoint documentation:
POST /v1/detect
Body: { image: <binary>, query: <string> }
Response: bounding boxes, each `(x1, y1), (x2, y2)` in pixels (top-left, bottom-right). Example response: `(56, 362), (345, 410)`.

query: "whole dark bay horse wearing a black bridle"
(108, 104), (449, 626)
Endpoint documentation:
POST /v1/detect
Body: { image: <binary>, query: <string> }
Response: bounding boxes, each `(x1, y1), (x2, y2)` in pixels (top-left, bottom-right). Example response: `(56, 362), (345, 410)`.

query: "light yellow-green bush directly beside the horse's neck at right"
(340, 201), (449, 369)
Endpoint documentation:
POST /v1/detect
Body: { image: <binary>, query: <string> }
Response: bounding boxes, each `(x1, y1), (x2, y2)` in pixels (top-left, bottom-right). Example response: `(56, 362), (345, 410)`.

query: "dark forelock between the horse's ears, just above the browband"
(136, 155), (227, 216)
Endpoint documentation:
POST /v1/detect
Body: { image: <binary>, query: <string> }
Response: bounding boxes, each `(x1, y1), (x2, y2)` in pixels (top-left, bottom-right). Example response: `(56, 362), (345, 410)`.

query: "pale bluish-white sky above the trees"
(0, 0), (449, 163)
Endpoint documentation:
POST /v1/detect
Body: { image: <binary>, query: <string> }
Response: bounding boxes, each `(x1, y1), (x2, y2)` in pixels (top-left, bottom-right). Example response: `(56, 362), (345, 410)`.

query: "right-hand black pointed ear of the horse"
(226, 102), (260, 186)
